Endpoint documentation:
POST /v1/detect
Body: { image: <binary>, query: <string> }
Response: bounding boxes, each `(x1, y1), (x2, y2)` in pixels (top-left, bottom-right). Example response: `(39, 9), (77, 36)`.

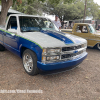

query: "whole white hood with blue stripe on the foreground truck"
(23, 30), (86, 48)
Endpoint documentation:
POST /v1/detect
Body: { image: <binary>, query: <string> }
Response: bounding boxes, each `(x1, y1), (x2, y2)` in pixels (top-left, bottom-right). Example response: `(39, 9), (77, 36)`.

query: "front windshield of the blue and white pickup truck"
(19, 16), (59, 32)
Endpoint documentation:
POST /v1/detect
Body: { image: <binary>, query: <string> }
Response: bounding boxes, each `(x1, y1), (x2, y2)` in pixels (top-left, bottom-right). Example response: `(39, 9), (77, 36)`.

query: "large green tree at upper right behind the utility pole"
(43, 0), (100, 20)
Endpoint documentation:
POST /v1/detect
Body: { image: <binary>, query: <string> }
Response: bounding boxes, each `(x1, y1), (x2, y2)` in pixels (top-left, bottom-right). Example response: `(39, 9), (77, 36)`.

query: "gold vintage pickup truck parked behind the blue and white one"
(62, 23), (100, 50)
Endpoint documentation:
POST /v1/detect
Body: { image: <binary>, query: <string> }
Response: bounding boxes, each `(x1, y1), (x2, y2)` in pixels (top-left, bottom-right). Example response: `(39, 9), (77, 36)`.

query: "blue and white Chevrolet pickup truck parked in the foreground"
(0, 14), (87, 75)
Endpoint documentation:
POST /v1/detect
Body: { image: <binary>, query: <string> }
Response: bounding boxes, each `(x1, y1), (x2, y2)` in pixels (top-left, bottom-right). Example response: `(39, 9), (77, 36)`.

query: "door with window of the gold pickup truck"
(73, 25), (89, 42)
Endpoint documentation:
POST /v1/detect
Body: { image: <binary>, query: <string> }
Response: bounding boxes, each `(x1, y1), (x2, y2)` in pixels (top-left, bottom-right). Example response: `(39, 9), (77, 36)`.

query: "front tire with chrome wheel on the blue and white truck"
(22, 49), (39, 76)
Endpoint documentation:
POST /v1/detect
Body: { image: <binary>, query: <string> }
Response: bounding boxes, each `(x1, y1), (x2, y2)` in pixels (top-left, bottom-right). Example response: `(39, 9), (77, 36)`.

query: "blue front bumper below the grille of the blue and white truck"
(37, 52), (87, 73)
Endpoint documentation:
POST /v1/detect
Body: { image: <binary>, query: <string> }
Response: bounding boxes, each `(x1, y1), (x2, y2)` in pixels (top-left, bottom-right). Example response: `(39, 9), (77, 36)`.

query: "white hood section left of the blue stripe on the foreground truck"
(22, 32), (66, 48)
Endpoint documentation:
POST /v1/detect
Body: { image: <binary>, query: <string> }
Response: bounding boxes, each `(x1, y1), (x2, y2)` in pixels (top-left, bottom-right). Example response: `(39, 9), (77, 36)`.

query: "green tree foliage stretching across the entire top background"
(0, 0), (100, 25)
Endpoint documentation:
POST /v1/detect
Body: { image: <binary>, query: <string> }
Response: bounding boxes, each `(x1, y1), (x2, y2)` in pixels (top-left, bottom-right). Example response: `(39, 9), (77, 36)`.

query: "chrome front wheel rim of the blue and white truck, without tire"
(23, 53), (33, 72)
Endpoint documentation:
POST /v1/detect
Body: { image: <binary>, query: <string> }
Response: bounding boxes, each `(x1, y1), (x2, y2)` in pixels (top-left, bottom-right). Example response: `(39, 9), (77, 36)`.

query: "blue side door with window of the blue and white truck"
(3, 16), (18, 52)
